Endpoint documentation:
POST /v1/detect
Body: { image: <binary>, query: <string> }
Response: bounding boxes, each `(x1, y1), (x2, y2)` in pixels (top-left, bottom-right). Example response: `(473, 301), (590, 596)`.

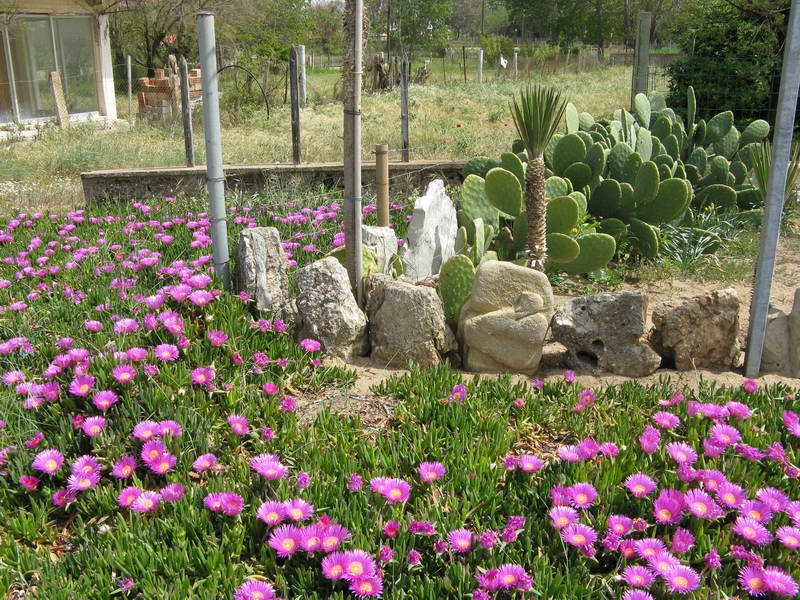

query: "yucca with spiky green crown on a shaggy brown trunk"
(511, 85), (567, 271)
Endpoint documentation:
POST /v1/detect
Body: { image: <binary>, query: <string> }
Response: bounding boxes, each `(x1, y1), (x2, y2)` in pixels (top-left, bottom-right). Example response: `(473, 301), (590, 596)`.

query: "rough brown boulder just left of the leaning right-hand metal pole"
(650, 288), (740, 371)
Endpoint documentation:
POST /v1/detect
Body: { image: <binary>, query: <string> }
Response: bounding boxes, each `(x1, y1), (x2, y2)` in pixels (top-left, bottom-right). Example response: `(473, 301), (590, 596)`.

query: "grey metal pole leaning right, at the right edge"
(744, 0), (800, 377)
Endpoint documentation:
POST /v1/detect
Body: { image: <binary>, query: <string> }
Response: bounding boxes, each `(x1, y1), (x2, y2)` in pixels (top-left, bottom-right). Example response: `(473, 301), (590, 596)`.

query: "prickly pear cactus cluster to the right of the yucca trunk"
(545, 88), (769, 257)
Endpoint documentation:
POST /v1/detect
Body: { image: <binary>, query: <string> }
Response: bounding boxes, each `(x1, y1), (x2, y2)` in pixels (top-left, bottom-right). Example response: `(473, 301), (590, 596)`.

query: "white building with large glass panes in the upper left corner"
(0, 0), (117, 130)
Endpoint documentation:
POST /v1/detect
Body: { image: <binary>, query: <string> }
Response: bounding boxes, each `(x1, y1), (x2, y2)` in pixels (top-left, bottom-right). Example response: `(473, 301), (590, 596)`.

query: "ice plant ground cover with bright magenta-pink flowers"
(0, 195), (800, 600)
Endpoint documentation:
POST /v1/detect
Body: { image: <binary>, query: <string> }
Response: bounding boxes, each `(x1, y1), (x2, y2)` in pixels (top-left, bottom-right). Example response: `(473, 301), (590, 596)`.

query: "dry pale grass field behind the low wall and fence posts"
(0, 67), (630, 208)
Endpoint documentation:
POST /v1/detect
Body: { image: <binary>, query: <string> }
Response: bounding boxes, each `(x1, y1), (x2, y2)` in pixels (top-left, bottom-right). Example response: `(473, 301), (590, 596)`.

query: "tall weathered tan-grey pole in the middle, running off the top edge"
(343, 0), (364, 300)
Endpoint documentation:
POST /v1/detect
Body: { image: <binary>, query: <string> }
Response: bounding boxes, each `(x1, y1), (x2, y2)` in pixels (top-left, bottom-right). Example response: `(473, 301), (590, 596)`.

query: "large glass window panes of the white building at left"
(0, 16), (99, 122)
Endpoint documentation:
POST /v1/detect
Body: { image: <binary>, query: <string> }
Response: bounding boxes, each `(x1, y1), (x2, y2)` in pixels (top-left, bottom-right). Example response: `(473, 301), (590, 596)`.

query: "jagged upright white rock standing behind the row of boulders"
(403, 179), (458, 281)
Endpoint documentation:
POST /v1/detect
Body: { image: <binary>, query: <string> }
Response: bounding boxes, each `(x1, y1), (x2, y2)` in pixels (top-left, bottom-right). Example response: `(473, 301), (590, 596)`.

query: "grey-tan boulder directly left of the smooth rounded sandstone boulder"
(367, 275), (457, 368)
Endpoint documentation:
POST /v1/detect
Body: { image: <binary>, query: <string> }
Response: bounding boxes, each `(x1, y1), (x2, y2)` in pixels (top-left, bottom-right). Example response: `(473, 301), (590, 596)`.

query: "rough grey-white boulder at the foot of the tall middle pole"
(295, 256), (368, 358)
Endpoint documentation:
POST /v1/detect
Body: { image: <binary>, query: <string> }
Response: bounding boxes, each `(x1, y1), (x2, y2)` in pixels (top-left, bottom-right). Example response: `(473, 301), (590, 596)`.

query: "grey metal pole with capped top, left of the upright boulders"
(197, 11), (231, 290)
